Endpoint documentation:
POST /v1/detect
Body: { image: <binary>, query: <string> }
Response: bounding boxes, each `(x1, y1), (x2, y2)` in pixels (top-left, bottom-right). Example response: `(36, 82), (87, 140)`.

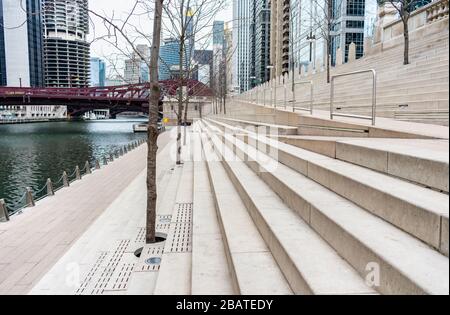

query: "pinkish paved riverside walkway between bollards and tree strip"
(0, 133), (174, 295)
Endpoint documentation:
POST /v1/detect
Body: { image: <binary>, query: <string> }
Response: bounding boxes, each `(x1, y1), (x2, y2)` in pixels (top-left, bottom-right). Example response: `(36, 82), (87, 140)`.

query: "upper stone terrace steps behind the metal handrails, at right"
(240, 17), (449, 126)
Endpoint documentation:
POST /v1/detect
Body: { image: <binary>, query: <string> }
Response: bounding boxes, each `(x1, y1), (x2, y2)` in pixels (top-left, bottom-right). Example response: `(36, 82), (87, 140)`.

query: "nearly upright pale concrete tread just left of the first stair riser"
(191, 133), (236, 295)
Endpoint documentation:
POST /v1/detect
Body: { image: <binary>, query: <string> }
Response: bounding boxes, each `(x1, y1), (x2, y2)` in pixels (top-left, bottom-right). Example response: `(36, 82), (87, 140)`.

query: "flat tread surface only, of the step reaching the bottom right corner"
(209, 123), (449, 294)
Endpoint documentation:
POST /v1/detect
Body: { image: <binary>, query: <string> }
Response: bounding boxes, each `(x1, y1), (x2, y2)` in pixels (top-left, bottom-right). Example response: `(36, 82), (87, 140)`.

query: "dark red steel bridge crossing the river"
(0, 80), (213, 116)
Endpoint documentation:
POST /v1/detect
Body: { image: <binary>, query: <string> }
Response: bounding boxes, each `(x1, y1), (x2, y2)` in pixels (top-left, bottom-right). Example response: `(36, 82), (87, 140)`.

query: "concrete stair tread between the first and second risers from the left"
(202, 128), (292, 295)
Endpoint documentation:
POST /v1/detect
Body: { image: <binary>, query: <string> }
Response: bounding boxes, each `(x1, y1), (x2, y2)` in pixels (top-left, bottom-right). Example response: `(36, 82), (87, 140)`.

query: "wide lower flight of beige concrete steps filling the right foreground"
(178, 118), (449, 294)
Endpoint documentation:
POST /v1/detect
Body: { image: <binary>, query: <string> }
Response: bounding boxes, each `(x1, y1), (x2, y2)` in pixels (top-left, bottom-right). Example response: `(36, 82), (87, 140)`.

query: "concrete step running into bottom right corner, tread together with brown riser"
(202, 119), (449, 294)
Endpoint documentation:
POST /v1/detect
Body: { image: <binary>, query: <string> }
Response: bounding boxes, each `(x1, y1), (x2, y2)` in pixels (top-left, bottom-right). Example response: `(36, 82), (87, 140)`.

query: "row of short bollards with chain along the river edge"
(0, 139), (146, 222)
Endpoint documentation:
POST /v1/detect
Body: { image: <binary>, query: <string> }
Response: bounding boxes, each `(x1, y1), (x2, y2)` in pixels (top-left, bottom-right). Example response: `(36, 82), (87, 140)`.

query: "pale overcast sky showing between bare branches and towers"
(89, 0), (232, 75)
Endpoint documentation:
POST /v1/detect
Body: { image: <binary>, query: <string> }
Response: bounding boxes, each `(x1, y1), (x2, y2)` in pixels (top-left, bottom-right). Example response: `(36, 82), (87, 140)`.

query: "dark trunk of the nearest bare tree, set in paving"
(146, 0), (163, 244)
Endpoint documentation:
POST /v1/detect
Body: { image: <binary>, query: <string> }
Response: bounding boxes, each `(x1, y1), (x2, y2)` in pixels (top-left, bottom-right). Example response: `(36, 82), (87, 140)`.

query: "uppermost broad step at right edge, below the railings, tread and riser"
(277, 136), (449, 192)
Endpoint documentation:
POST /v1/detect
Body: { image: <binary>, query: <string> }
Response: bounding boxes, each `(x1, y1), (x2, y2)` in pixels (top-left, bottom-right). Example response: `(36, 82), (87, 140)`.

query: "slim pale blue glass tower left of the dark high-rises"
(233, 0), (252, 93)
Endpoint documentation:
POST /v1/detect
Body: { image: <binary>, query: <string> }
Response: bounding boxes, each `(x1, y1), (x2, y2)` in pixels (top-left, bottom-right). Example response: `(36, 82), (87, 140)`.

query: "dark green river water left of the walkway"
(0, 119), (146, 203)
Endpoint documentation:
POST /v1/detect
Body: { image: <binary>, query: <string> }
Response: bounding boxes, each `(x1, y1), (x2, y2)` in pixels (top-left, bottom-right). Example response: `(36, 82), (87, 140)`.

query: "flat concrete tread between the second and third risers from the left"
(206, 126), (375, 294)
